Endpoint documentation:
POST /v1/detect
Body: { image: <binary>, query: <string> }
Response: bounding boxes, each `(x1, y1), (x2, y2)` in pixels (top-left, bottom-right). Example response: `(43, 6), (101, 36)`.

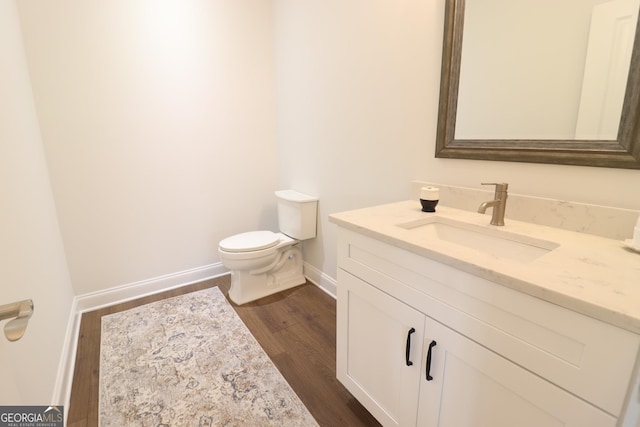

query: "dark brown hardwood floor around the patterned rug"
(67, 276), (380, 427)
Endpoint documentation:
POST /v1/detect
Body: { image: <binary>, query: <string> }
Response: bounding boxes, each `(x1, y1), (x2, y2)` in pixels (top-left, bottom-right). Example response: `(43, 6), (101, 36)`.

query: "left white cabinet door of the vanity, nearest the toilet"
(336, 269), (425, 426)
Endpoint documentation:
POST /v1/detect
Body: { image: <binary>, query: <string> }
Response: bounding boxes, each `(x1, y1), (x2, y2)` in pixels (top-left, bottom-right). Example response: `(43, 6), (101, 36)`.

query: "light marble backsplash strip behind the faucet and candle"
(411, 181), (640, 240)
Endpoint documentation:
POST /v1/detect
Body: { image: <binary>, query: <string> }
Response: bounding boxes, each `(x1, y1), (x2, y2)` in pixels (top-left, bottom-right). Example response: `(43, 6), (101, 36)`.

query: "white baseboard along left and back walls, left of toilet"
(51, 263), (229, 412)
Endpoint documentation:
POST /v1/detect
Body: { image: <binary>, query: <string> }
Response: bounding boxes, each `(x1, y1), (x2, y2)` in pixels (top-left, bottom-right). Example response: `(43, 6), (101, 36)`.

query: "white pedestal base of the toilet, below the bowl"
(229, 244), (306, 305)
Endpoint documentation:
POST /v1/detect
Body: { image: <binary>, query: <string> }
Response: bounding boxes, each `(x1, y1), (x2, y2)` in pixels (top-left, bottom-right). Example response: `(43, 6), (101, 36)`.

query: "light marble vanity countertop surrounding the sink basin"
(329, 200), (640, 333)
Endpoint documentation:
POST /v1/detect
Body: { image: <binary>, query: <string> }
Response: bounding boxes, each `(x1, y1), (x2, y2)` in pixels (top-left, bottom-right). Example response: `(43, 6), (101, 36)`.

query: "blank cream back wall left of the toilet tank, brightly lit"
(19, 0), (278, 294)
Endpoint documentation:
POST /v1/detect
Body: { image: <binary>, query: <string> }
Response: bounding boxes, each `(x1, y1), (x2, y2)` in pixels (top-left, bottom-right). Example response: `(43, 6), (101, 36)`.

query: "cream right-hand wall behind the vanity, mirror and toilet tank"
(275, 0), (640, 278)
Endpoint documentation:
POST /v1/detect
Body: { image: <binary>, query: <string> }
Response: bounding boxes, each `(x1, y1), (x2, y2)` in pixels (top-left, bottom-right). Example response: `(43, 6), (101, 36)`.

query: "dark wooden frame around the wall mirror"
(436, 0), (640, 169)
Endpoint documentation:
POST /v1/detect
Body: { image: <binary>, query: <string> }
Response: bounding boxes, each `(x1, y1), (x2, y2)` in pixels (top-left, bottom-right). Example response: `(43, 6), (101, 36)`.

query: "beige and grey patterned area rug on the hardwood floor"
(100, 288), (317, 427)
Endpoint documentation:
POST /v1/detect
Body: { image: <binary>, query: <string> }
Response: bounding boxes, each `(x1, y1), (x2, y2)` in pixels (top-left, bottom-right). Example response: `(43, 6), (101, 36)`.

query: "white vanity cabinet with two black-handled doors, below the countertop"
(337, 228), (639, 427)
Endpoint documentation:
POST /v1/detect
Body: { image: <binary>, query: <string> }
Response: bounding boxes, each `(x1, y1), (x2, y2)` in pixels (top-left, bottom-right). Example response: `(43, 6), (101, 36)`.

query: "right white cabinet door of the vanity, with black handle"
(417, 318), (616, 427)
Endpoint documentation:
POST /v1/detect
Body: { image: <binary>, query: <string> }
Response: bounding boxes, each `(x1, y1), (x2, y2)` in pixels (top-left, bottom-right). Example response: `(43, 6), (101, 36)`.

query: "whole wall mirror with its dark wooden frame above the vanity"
(436, 0), (640, 169)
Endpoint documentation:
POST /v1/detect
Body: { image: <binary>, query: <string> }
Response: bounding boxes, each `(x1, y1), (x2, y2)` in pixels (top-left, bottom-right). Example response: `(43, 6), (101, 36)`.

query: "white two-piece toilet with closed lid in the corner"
(218, 190), (318, 305)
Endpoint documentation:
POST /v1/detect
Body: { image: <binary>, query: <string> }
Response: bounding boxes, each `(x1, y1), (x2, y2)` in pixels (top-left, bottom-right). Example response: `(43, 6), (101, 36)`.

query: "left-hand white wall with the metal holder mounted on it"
(0, 1), (73, 405)
